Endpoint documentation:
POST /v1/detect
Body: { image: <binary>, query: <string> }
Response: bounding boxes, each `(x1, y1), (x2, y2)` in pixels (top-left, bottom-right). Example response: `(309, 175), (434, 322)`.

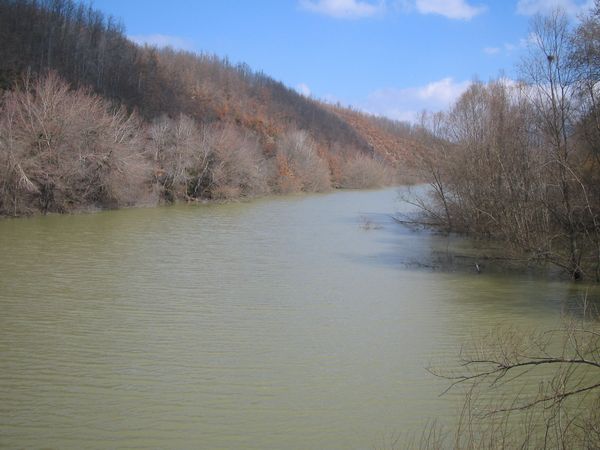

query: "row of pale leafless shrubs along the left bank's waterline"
(0, 73), (394, 216)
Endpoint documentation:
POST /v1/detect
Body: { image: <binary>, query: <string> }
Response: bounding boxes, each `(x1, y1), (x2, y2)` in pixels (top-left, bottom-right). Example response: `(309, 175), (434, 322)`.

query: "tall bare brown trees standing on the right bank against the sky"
(419, 6), (600, 281)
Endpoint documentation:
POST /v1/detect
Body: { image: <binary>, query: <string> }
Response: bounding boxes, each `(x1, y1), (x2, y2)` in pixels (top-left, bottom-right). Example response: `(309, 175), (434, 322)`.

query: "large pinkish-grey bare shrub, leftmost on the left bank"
(0, 74), (147, 215)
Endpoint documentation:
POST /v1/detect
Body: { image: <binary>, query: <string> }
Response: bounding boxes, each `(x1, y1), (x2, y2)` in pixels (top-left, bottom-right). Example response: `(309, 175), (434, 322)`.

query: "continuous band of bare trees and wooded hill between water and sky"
(0, 0), (600, 281)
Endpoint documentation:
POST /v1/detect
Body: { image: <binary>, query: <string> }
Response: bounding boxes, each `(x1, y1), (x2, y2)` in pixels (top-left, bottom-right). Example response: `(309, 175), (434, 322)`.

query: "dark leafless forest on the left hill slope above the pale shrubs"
(0, 0), (371, 152)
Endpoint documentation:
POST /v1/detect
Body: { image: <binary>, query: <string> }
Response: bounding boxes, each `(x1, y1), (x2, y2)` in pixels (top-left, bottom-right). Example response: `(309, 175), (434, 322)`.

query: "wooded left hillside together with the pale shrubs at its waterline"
(0, 0), (402, 215)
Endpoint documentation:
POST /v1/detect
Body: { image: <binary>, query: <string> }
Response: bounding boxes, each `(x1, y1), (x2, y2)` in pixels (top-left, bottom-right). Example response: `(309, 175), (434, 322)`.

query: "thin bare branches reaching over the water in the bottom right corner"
(432, 304), (600, 449)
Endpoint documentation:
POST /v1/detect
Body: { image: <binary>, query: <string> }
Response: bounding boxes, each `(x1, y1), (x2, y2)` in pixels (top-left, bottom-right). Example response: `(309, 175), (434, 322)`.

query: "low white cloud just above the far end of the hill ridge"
(359, 77), (471, 122)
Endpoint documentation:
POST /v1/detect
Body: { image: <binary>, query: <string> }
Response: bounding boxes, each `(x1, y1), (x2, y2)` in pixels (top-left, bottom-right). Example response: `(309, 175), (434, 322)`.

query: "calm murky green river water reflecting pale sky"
(0, 189), (592, 449)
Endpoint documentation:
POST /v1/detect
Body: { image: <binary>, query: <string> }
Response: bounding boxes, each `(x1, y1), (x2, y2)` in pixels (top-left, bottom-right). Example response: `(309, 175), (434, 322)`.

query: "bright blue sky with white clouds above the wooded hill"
(93, 0), (593, 120)
